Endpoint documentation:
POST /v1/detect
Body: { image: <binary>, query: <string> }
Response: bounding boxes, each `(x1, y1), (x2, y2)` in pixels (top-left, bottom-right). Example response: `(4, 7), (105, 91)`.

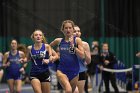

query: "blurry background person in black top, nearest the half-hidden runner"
(88, 41), (101, 93)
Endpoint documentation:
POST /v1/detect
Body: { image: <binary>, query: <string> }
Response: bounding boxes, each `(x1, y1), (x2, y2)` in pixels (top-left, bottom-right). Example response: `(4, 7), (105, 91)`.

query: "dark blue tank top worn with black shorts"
(30, 43), (49, 75)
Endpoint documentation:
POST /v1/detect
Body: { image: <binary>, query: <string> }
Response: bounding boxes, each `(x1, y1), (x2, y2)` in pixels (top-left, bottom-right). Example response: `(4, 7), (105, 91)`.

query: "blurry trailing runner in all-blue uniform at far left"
(3, 39), (26, 93)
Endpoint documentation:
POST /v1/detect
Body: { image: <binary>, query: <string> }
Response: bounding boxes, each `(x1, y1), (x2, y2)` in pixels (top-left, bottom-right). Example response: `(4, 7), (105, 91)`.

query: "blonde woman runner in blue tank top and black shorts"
(27, 29), (58, 93)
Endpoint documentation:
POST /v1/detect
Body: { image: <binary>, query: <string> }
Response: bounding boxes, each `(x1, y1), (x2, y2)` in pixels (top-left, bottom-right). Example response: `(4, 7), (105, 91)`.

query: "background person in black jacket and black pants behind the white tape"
(100, 43), (119, 93)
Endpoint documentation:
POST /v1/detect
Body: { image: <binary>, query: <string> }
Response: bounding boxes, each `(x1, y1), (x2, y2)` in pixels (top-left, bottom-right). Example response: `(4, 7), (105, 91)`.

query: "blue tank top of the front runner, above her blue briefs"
(58, 37), (79, 72)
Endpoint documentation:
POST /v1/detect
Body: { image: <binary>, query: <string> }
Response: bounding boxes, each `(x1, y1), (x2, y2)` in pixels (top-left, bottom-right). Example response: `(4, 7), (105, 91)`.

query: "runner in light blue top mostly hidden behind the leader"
(74, 25), (91, 93)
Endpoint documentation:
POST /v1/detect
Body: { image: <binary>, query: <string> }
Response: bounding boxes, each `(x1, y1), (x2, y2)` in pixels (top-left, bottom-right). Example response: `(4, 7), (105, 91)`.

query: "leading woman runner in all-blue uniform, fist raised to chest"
(50, 20), (84, 93)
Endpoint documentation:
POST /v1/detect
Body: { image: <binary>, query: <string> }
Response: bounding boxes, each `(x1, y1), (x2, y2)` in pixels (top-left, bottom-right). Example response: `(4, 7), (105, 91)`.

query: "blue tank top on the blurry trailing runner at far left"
(6, 51), (21, 73)
